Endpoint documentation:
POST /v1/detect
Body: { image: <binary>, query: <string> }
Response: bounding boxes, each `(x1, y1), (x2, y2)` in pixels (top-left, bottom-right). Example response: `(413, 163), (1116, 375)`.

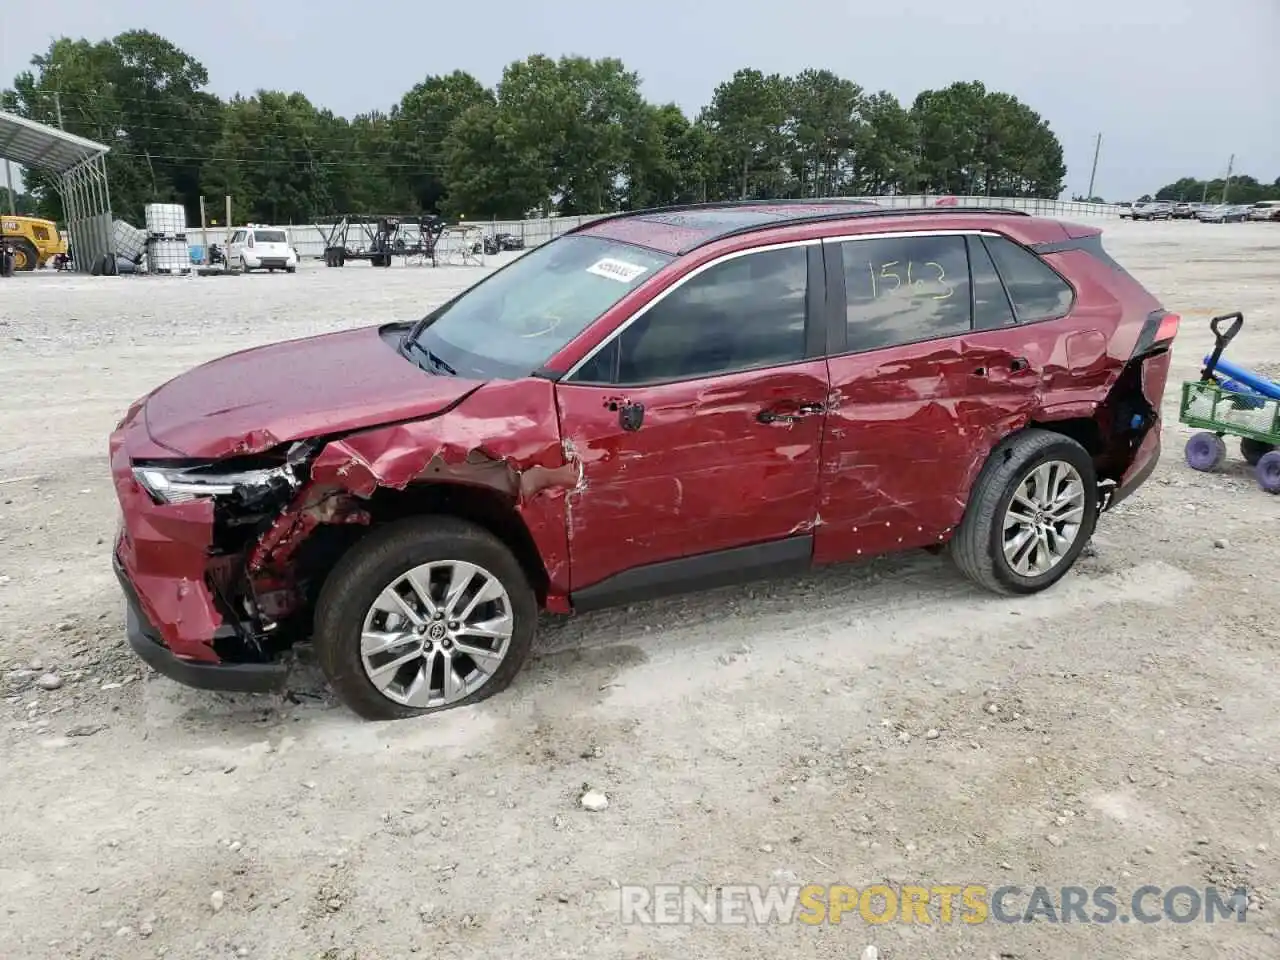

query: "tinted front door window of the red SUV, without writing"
(604, 247), (809, 384)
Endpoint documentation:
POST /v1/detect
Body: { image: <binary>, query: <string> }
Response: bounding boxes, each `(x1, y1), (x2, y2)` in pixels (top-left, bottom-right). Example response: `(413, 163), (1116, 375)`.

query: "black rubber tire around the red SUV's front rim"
(314, 516), (538, 721)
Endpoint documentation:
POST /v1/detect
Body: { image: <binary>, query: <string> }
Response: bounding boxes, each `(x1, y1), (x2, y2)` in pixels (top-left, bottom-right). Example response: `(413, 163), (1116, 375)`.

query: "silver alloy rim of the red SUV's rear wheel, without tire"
(1004, 460), (1085, 577)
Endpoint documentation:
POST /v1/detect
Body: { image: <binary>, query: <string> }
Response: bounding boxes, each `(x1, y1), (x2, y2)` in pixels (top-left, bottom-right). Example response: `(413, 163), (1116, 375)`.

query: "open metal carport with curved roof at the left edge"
(0, 110), (114, 273)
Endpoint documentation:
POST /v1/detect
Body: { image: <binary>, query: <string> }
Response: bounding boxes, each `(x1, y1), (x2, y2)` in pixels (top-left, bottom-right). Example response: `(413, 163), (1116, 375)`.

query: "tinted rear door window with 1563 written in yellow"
(841, 237), (970, 352)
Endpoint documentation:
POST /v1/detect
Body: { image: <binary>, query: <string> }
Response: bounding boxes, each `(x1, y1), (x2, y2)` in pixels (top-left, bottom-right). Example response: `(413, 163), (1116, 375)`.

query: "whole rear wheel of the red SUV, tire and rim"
(950, 430), (1098, 594)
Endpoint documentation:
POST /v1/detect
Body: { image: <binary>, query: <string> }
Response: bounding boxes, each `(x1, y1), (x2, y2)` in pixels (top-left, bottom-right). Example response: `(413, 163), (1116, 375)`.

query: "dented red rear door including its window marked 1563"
(814, 232), (1038, 562)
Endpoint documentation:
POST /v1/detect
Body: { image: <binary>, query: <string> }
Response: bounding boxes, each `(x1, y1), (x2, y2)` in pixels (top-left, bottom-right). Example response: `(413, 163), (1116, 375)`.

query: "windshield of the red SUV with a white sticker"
(406, 236), (673, 379)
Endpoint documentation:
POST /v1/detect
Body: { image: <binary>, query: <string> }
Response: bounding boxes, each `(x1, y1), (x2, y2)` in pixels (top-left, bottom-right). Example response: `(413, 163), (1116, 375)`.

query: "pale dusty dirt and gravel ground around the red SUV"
(0, 221), (1280, 960)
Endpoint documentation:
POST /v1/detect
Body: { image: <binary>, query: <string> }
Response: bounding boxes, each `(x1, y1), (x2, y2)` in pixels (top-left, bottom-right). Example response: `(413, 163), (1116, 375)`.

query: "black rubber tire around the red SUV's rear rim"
(948, 429), (1098, 594)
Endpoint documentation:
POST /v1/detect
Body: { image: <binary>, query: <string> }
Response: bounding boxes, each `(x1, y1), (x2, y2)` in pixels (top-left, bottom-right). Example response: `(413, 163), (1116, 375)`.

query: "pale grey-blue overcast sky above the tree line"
(0, 0), (1280, 201)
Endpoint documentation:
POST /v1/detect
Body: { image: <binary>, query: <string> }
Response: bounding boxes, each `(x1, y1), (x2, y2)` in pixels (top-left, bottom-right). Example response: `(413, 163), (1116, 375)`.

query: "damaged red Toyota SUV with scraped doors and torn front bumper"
(110, 201), (1178, 718)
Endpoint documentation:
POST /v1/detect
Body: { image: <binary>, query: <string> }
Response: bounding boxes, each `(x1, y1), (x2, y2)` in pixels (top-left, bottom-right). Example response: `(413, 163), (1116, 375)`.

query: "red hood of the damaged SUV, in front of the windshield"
(143, 326), (481, 460)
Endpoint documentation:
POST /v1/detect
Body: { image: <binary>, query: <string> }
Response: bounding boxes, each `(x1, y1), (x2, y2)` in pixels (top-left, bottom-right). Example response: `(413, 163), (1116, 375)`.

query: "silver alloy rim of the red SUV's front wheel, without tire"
(360, 561), (515, 708)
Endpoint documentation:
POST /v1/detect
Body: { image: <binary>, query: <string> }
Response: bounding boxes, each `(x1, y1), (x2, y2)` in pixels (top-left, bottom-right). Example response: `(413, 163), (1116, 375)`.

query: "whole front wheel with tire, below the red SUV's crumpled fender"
(314, 516), (538, 719)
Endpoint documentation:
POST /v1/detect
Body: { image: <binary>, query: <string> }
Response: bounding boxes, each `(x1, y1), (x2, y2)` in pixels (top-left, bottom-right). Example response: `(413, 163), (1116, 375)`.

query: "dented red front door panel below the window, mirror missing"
(556, 360), (827, 590)
